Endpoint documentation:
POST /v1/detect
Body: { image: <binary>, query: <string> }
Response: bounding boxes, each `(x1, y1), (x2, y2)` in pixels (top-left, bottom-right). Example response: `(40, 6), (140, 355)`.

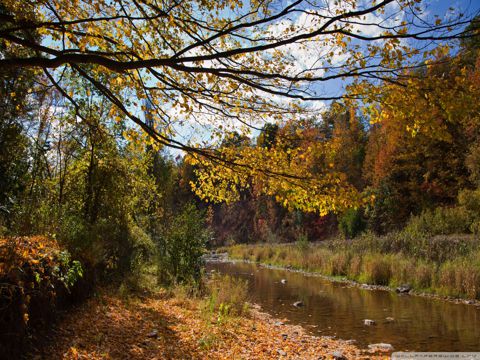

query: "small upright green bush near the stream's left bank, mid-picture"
(158, 203), (212, 284)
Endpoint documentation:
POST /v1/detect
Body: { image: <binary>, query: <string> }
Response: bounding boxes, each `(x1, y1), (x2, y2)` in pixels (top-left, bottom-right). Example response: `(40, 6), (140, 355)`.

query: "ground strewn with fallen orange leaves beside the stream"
(32, 293), (386, 359)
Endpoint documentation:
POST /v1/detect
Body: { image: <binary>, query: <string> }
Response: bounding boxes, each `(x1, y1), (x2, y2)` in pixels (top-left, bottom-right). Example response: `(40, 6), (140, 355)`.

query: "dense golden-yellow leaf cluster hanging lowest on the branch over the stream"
(188, 131), (365, 215)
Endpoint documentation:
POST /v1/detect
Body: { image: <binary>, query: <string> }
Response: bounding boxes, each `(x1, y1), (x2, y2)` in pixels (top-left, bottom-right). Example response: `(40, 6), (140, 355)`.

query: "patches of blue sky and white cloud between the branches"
(40, 0), (480, 156)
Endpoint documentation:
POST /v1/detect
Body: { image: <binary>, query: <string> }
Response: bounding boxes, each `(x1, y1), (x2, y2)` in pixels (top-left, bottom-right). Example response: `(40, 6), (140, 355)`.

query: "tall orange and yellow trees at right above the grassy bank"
(364, 38), (480, 231)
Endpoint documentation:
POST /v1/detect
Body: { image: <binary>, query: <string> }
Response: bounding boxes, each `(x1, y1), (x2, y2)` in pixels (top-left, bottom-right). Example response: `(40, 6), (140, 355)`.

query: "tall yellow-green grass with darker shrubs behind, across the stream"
(219, 232), (480, 300)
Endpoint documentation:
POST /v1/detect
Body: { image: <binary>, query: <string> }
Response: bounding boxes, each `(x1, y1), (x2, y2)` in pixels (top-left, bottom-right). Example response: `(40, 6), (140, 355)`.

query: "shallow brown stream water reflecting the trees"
(207, 263), (480, 351)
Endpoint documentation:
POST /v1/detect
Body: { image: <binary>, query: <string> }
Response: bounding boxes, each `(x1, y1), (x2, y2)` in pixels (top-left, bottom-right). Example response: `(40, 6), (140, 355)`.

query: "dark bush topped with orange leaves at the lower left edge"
(0, 236), (86, 359)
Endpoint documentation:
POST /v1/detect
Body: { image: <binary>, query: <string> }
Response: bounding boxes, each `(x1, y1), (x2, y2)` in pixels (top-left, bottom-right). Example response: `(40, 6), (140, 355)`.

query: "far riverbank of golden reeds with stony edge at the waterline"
(217, 241), (480, 305)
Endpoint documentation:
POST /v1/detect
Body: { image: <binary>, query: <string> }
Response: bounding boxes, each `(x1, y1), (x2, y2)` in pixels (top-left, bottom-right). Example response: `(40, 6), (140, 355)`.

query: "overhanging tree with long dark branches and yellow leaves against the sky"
(0, 0), (474, 213)
